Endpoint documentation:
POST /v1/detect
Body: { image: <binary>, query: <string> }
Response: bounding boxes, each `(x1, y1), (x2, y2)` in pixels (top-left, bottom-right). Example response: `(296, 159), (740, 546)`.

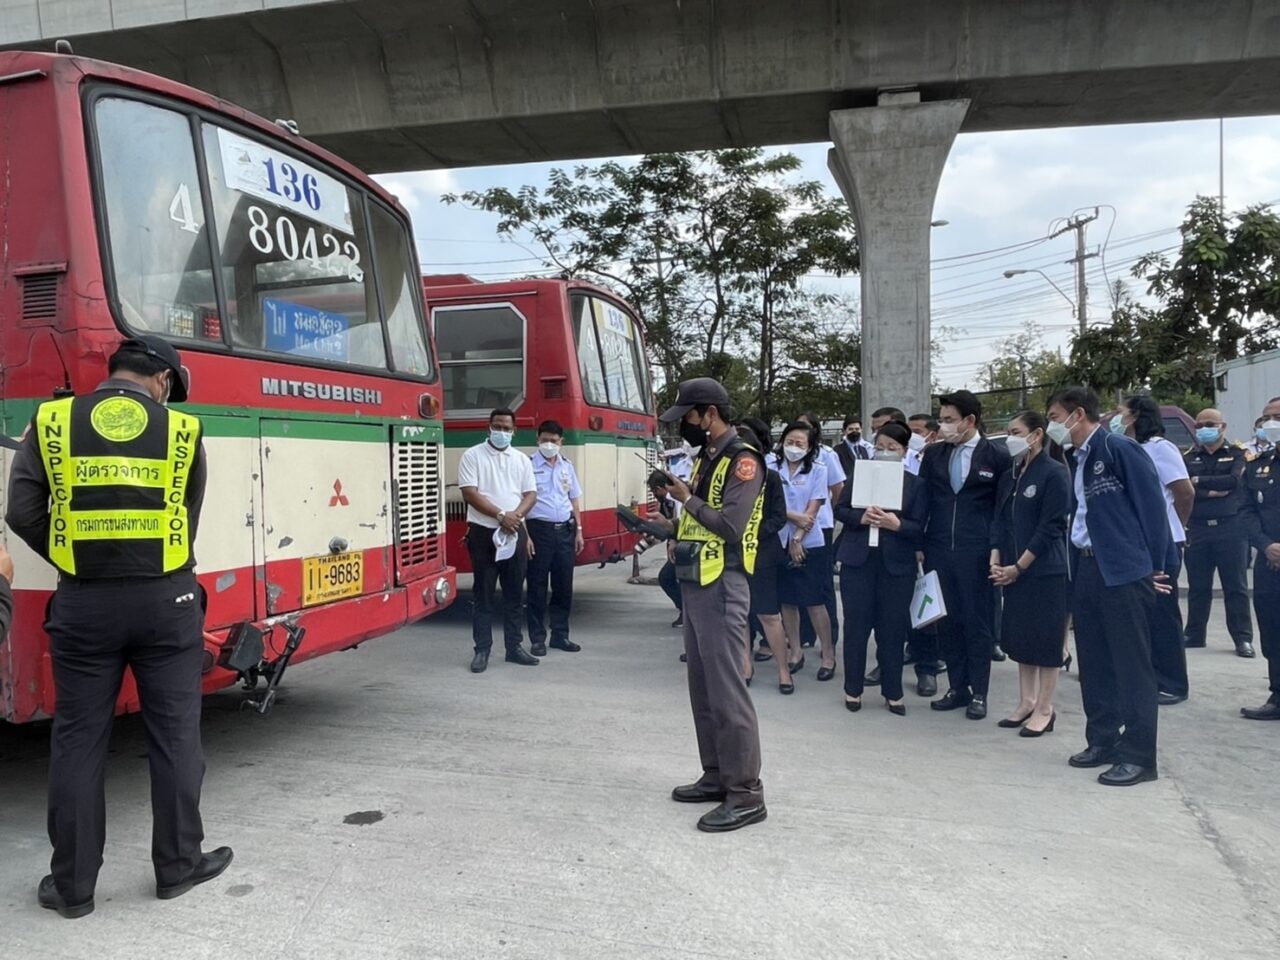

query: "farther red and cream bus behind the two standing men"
(422, 275), (658, 572)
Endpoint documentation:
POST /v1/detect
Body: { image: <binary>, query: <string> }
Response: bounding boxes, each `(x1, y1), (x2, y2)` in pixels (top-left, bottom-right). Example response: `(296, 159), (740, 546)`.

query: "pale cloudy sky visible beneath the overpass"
(378, 116), (1280, 389)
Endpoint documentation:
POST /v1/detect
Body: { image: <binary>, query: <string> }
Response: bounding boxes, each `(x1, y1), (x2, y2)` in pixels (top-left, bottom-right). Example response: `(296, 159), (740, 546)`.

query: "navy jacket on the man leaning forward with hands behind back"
(1068, 428), (1171, 586)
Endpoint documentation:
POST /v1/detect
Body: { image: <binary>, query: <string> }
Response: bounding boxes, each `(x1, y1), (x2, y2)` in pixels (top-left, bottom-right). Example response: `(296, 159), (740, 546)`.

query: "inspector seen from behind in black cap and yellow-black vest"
(5, 337), (232, 918)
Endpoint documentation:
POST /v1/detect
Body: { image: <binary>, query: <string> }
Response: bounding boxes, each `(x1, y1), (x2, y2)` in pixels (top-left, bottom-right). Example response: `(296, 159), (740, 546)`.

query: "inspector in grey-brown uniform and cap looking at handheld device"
(659, 378), (768, 833)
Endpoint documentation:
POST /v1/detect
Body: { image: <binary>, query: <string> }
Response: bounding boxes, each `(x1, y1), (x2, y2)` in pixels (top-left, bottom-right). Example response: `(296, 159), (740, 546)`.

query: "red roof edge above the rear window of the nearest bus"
(0, 50), (407, 216)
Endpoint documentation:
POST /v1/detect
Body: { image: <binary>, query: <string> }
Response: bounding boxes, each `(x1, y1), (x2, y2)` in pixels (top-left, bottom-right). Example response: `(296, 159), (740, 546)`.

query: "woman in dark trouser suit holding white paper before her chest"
(836, 420), (928, 717)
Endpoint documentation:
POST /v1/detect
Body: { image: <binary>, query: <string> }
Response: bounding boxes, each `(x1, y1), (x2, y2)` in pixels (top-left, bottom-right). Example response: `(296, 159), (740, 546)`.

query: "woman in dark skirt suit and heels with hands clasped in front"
(991, 411), (1071, 737)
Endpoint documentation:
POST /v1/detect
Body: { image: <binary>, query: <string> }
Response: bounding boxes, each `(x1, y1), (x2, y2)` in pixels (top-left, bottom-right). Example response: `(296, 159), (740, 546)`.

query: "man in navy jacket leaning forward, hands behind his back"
(1048, 387), (1170, 787)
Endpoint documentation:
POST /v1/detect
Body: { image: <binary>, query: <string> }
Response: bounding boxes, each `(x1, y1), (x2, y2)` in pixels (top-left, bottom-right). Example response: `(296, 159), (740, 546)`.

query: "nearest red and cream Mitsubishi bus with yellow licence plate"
(0, 51), (454, 722)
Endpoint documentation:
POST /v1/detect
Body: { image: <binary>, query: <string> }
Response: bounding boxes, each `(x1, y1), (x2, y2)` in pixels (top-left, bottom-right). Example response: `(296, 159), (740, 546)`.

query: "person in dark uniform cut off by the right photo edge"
(1240, 397), (1280, 719)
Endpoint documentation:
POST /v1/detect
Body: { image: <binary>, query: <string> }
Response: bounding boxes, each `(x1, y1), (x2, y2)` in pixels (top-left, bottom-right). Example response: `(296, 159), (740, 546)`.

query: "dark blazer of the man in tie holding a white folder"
(920, 436), (1012, 550)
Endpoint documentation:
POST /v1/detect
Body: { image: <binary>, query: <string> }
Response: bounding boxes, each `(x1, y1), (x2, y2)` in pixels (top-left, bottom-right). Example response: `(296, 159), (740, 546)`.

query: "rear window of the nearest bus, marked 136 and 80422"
(93, 95), (433, 378)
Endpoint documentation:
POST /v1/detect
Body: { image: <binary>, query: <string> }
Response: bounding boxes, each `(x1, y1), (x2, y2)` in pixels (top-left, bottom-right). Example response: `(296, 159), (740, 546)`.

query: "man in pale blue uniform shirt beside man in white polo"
(525, 420), (582, 657)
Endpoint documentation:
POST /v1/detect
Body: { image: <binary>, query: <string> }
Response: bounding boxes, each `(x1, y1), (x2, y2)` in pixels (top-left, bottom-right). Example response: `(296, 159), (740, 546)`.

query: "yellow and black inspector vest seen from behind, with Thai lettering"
(36, 393), (201, 577)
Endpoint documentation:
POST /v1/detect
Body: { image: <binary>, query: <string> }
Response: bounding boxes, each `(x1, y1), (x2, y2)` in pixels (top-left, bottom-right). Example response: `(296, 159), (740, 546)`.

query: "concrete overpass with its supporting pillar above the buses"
(0, 0), (1280, 419)
